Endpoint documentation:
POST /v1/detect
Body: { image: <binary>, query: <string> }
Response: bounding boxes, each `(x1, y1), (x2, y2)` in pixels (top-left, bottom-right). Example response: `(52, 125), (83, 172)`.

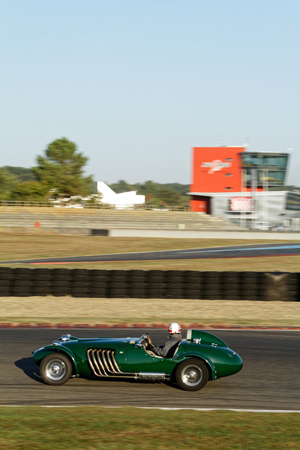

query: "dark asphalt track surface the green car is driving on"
(0, 329), (300, 411)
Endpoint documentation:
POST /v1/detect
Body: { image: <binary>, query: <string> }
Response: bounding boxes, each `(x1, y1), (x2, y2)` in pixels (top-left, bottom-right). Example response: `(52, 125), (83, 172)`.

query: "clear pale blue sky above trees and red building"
(0, 0), (300, 185)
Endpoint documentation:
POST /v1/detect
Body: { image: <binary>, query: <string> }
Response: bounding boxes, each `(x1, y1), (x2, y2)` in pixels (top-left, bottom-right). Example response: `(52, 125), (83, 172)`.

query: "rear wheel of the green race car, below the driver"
(175, 358), (209, 391)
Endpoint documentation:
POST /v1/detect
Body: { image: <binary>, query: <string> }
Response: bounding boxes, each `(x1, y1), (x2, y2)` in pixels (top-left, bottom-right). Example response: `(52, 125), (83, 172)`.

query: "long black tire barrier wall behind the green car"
(0, 267), (300, 301)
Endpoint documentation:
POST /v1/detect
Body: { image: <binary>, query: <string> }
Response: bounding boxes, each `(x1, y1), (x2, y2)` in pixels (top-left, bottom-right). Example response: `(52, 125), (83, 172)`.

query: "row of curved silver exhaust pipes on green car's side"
(87, 348), (122, 377)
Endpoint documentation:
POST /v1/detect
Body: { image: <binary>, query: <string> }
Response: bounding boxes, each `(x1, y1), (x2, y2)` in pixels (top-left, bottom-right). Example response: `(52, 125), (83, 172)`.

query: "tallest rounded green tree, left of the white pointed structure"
(33, 138), (93, 197)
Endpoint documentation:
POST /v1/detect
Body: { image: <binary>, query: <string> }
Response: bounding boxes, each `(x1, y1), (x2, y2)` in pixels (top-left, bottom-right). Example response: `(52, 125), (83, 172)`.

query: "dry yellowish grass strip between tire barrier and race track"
(0, 297), (300, 327)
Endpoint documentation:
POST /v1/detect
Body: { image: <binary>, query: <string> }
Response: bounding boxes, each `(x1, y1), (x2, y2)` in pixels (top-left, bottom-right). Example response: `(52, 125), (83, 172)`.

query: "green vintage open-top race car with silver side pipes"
(33, 330), (243, 391)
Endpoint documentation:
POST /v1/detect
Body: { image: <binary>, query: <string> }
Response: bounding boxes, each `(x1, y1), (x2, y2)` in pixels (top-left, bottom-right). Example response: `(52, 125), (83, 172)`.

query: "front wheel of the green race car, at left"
(40, 352), (73, 386)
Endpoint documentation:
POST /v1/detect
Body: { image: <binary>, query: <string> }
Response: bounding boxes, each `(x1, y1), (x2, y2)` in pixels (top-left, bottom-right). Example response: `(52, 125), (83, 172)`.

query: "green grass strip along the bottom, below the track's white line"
(0, 407), (300, 450)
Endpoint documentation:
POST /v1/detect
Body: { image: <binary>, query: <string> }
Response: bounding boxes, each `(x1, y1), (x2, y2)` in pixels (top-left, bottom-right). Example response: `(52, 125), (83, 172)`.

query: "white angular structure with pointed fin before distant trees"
(96, 181), (145, 209)
